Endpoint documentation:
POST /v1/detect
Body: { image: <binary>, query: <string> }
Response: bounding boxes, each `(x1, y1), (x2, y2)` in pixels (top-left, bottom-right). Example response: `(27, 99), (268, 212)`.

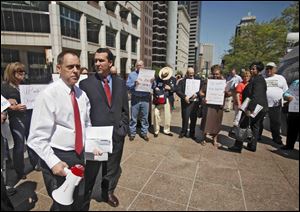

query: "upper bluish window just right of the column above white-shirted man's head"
(60, 6), (80, 39)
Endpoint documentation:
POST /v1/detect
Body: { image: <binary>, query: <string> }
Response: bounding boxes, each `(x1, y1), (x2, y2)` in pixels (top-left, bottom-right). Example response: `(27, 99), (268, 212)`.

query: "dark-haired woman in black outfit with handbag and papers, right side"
(229, 62), (268, 153)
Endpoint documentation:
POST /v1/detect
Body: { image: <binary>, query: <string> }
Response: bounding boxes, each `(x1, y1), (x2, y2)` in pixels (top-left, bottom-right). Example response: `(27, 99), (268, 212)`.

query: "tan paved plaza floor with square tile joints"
(7, 102), (299, 211)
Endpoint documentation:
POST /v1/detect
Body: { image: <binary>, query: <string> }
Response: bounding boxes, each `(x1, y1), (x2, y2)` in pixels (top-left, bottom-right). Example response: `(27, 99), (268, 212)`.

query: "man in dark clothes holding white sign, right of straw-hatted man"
(176, 67), (201, 140)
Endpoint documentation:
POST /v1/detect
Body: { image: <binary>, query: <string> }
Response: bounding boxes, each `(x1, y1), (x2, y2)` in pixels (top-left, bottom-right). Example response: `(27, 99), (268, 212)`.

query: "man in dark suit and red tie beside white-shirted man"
(79, 48), (129, 209)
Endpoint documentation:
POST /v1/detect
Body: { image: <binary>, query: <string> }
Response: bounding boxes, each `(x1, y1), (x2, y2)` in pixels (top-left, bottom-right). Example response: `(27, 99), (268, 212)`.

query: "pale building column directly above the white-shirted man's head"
(49, 1), (62, 73)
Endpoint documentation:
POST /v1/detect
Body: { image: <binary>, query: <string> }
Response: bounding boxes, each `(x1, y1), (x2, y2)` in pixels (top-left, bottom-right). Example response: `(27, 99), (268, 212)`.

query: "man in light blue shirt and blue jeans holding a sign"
(126, 60), (154, 141)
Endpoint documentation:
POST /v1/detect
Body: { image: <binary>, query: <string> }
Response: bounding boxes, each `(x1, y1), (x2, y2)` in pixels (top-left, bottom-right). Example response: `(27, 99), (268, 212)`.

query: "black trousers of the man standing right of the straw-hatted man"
(181, 100), (200, 135)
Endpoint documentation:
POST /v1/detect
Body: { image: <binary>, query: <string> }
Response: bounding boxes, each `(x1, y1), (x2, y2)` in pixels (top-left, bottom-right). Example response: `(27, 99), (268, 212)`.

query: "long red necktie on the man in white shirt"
(71, 89), (83, 155)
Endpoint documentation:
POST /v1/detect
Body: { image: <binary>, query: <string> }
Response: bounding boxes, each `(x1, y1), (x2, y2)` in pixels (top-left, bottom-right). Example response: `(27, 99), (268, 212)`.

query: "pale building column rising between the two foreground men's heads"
(80, 14), (89, 67)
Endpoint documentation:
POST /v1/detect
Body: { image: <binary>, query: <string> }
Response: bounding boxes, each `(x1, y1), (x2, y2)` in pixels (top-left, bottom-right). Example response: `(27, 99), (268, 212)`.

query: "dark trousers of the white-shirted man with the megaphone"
(41, 148), (84, 211)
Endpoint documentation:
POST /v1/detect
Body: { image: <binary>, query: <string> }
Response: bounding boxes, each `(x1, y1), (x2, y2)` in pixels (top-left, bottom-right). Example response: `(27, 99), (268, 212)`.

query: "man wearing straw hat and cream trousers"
(153, 67), (176, 137)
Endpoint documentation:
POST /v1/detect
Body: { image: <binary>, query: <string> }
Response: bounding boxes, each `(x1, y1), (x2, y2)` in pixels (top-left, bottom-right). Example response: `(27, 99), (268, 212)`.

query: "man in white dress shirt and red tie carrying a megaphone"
(28, 51), (91, 211)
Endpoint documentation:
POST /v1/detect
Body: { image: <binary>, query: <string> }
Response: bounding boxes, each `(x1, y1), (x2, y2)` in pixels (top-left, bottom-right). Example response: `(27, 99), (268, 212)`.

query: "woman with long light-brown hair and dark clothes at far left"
(1, 62), (29, 179)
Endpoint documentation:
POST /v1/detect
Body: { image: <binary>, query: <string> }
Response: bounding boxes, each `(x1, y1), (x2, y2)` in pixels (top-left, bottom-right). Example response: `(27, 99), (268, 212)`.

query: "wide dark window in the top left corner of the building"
(1, 1), (50, 33)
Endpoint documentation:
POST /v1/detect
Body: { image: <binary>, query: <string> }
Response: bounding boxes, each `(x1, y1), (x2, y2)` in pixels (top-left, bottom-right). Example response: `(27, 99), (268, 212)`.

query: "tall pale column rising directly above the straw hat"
(166, 1), (178, 70)
